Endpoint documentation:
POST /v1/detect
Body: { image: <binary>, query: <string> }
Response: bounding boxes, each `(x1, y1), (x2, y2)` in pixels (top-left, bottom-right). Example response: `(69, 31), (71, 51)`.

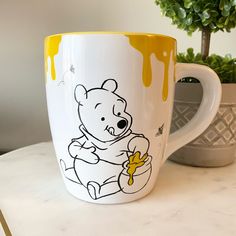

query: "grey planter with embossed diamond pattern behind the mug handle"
(169, 83), (236, 167)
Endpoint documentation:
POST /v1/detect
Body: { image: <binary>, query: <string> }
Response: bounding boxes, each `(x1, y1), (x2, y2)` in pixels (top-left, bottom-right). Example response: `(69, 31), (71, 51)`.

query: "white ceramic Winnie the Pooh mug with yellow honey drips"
(45, 32), (221, 204)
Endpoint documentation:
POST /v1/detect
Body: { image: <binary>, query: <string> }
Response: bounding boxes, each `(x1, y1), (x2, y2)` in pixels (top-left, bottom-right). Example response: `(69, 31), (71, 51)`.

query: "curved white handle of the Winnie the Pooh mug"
(162, 63), (221, 164)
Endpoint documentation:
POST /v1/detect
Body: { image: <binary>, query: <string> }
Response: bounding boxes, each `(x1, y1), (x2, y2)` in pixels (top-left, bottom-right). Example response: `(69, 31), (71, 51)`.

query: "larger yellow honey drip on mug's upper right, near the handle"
(126, 35), (175, 101)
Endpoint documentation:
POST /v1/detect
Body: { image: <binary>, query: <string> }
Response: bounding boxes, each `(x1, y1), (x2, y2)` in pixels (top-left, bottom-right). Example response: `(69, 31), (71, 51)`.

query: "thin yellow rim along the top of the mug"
(45, 31), (177, 41)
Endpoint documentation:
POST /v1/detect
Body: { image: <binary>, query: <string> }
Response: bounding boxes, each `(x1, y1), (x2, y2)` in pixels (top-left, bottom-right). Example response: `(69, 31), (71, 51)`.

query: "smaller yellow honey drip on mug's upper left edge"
(44, 35), (61, 80)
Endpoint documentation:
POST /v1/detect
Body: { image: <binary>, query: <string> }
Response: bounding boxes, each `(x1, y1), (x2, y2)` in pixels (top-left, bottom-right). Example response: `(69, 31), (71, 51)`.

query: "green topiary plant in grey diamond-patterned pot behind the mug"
(155, 0), (236, 167)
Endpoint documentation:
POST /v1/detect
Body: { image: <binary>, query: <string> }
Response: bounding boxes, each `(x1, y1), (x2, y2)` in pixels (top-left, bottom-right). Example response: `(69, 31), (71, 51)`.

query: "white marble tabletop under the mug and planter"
(0, 143), (236, 236)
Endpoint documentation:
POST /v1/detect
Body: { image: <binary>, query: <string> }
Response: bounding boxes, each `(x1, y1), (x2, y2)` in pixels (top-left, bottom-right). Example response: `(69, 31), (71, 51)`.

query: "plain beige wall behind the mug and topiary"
(0, 0), (236, 151)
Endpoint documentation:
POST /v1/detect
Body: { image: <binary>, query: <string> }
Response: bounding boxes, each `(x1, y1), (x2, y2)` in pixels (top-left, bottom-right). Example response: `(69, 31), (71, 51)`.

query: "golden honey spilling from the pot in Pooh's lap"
(127, 151), (148, 185)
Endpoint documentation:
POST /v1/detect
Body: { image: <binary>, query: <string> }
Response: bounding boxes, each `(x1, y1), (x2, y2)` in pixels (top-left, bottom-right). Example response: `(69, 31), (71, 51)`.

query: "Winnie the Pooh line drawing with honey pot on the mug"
(60, 79), (152, 200)
